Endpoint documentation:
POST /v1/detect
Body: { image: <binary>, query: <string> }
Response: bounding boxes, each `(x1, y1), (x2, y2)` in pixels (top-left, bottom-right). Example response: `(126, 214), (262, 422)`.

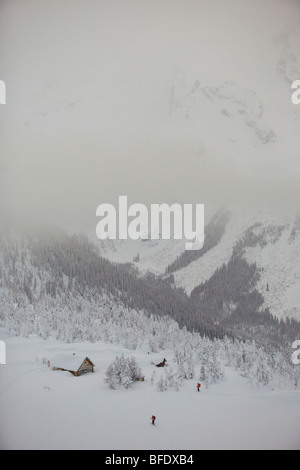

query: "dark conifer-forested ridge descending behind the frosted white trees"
(0, 217), (300, 347)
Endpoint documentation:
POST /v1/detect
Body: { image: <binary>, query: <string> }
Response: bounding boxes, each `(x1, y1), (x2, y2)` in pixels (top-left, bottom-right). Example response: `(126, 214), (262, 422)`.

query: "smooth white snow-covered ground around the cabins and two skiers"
(0, 329), (300, 450)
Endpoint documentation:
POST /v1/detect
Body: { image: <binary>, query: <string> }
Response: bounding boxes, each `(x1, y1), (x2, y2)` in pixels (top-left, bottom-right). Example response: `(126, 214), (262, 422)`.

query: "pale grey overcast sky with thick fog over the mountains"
(0, 0), (300, 233)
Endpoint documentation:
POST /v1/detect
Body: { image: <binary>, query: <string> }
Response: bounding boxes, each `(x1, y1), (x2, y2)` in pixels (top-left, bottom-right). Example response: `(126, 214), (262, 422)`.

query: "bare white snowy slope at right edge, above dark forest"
(174, 207), (300, 320)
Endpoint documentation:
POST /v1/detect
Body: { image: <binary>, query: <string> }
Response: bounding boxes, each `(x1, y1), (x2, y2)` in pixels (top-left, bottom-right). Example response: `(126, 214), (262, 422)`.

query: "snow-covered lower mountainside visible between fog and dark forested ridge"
(97, 208), (300, 320)
